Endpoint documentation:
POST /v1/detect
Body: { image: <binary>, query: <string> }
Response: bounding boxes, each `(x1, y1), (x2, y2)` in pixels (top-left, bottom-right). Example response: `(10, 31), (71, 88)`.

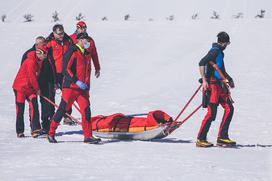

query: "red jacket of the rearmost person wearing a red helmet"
(70, 33), (100, 70)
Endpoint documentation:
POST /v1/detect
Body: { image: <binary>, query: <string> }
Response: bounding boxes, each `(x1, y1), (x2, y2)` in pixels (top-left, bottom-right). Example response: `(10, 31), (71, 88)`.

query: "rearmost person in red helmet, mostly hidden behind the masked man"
(70, 21), (101, 78)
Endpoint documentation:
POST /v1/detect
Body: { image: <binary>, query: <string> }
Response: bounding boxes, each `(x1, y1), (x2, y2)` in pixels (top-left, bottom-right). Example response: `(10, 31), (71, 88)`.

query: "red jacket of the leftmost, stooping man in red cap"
(12, 52), (43, 96)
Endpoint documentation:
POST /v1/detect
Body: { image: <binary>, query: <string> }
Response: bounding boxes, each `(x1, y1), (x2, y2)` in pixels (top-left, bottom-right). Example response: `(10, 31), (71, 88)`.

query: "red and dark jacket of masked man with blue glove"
(63, 45), (91, 89)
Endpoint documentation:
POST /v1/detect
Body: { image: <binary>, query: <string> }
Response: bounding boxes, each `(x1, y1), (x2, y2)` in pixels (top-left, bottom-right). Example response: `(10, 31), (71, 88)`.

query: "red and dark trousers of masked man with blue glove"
(49, 88), (92, 139)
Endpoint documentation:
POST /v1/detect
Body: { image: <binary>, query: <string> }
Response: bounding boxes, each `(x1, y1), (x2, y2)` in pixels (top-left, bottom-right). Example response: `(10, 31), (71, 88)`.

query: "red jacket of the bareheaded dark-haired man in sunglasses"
(46, 33), (73, 73)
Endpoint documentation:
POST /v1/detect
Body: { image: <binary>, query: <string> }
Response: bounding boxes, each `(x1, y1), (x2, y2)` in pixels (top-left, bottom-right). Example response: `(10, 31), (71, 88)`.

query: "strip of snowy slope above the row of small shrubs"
(0, 0), (272, 23)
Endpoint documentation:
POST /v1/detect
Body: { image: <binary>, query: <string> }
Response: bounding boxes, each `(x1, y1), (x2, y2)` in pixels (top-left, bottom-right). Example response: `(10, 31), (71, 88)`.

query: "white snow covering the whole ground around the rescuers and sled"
(0, 0), (272, 181)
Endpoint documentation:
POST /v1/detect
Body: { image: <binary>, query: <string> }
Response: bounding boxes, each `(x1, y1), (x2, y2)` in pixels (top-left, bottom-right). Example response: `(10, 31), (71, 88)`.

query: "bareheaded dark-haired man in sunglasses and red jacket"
(46, 24), (75, 125)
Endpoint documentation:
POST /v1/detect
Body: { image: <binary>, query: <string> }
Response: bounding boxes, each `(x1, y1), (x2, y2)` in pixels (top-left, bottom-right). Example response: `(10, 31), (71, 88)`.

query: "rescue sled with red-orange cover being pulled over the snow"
(92, 110), (173, 140)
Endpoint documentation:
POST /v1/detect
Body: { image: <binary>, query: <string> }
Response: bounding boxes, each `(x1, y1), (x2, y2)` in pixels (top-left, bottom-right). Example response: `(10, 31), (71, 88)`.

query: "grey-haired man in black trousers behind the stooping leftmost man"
(21, 36), (55, 134)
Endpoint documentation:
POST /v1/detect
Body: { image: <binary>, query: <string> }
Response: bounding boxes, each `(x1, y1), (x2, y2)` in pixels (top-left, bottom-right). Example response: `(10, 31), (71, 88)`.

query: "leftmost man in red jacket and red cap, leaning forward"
(12, 46), (47, 138)
